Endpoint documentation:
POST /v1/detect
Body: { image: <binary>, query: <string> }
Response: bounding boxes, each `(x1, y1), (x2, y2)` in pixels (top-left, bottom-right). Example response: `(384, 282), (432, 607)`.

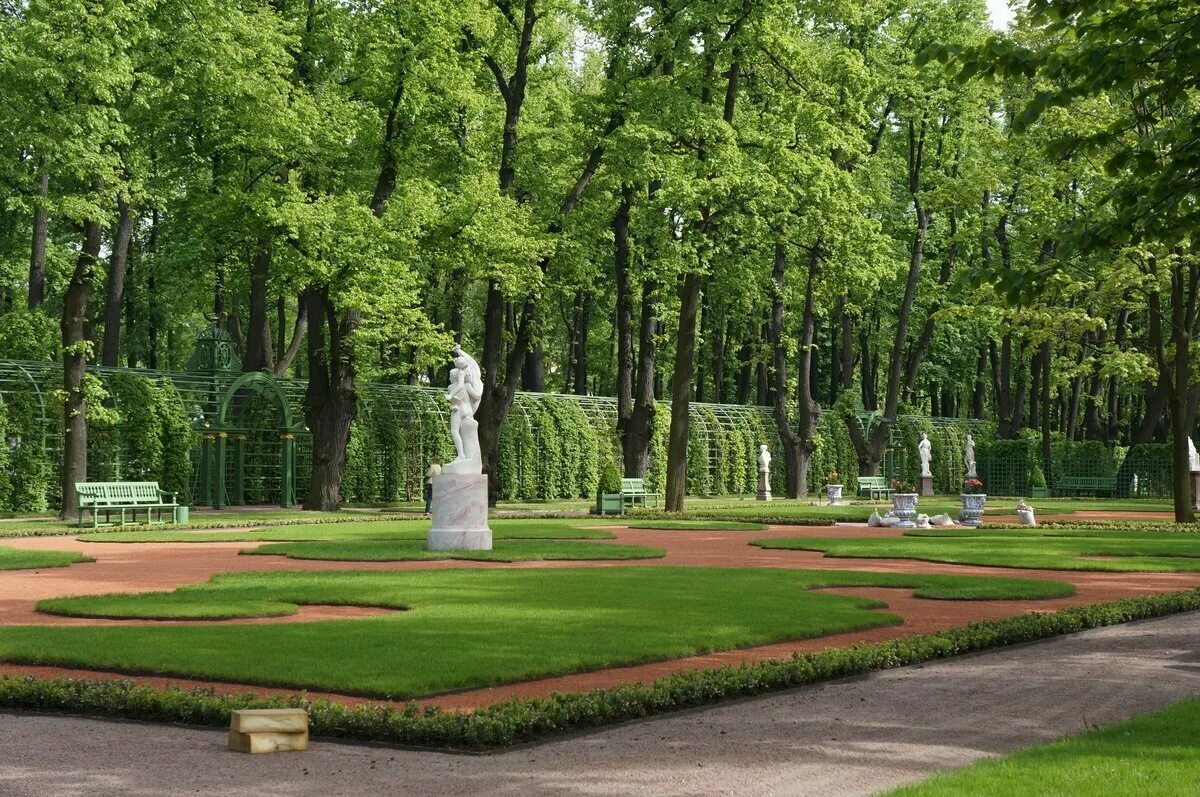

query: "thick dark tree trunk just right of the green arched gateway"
(304, 288), (359, 511)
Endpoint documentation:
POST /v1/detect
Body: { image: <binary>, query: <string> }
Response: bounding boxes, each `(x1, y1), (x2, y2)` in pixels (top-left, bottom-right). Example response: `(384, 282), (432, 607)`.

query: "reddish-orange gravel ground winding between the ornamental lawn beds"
(0, 523), (1200, 708)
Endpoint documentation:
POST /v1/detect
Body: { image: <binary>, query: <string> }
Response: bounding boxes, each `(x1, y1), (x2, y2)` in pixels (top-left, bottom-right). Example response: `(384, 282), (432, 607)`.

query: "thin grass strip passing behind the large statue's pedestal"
(79, 517), (613, 543)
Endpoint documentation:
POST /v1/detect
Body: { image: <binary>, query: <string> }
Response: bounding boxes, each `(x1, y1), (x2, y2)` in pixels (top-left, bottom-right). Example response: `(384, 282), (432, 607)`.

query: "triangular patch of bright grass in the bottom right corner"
(890, 700), (1200, 797)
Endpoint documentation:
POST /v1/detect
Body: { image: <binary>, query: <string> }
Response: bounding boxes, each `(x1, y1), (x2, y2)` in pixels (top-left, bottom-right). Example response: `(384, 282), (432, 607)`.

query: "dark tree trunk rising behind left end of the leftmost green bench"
(59, 214), (100, 520)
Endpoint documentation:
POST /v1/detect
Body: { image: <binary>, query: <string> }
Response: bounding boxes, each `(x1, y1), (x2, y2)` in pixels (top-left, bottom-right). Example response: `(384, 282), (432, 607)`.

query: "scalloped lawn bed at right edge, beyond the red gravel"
(751, 529), (1200, 573)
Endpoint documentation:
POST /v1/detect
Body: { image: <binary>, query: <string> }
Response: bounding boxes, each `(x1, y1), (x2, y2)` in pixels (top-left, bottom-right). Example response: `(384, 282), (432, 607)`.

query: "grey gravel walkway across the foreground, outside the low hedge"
(0, 613), (1200, 797)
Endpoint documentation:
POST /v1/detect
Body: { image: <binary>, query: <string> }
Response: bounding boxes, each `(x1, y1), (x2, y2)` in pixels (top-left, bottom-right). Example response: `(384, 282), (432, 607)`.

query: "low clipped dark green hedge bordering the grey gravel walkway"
(0, 589), (1200, 750)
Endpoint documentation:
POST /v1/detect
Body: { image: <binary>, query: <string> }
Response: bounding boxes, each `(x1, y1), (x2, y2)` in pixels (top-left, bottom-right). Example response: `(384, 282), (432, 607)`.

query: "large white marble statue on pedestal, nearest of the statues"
(426, 346), (492, 551)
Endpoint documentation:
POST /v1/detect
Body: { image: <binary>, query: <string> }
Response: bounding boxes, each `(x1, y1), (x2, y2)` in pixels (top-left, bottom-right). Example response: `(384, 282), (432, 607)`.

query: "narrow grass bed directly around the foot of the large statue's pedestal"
(242, 540), (666, 562)
